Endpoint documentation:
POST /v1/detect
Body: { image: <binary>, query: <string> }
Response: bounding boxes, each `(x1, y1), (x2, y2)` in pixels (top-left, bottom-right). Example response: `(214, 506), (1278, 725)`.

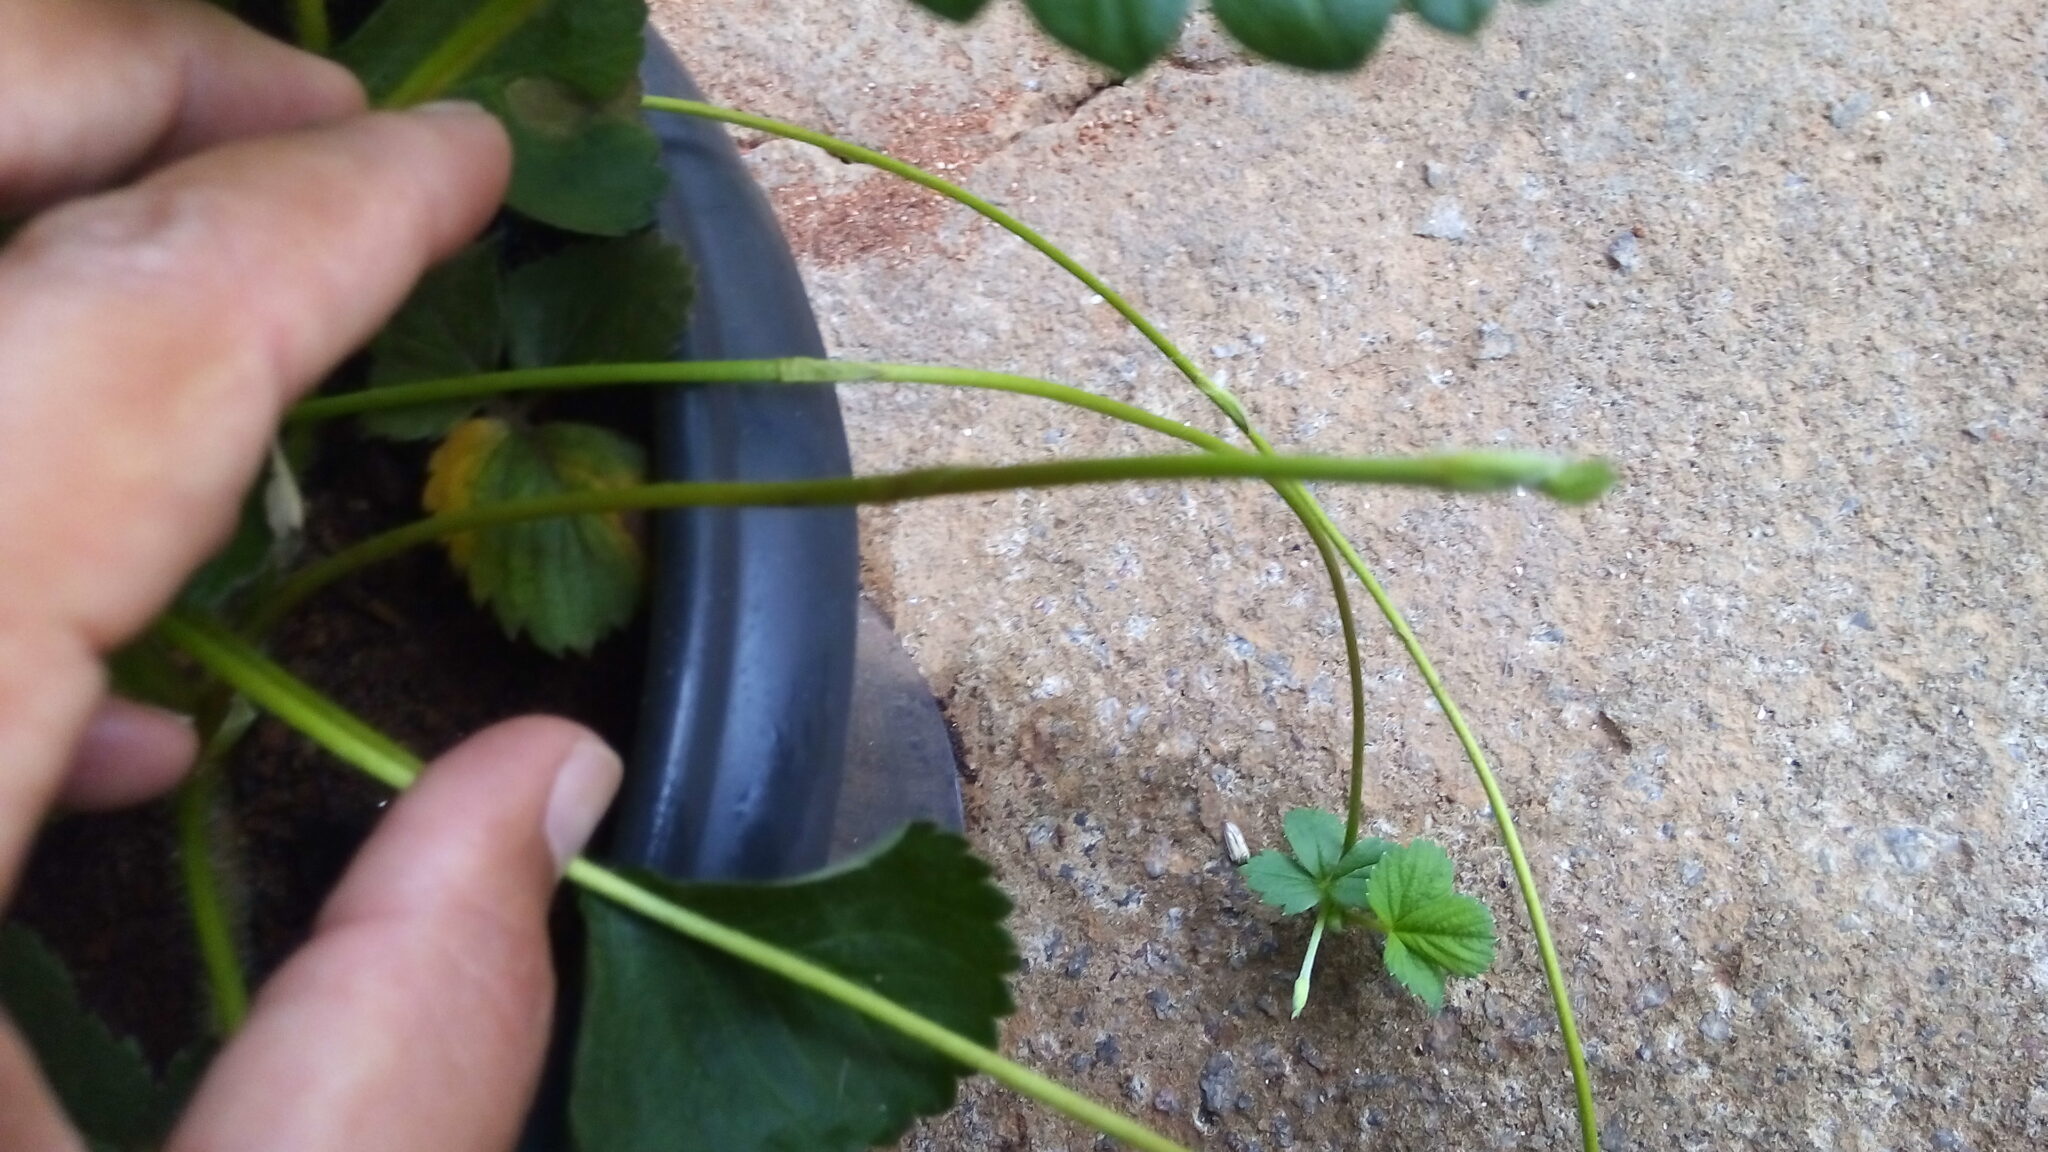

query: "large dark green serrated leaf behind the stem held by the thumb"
(569, 824), (1018, 1152)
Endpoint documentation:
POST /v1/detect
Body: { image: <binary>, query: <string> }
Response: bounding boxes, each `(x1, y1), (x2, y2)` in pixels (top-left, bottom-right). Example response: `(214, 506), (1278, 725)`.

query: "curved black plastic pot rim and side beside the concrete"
(606, 33), (860, 879)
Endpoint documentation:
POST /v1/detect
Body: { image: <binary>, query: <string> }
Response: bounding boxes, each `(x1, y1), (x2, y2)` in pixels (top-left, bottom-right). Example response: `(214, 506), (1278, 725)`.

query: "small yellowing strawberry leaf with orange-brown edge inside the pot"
(426, 418), (645, 656)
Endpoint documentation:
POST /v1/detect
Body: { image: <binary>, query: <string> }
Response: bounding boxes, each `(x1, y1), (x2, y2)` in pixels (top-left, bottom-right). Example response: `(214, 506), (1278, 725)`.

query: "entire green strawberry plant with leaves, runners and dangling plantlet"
(0, 0), (1612, 1152)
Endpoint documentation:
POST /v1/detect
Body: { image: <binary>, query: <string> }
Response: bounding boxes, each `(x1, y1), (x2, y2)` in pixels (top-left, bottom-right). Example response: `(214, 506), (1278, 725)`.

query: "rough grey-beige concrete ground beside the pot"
(657, 0), (2048, 1152)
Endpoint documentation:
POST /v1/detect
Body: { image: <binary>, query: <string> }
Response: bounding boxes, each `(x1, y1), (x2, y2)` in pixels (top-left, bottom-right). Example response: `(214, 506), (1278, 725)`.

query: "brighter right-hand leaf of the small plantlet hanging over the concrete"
(1368, 840), (1495, 1011)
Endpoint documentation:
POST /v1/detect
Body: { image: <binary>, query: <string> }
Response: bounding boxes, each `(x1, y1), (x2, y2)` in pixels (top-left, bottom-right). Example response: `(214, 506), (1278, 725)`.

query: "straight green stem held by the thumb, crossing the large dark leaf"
(156, 611), (1186, 1152)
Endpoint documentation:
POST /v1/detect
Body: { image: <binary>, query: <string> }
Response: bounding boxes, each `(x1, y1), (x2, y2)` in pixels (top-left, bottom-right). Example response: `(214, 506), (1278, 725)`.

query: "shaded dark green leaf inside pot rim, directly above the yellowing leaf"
(504, 232), (690, 369)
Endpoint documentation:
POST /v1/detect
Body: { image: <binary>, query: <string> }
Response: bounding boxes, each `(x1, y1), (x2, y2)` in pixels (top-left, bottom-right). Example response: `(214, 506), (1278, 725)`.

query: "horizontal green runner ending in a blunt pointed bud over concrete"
(250, 451), (1608, 635)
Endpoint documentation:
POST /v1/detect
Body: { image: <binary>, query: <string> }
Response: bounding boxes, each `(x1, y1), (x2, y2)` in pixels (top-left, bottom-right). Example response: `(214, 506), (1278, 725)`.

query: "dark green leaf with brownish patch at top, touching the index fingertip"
(336, 0), (666, 236)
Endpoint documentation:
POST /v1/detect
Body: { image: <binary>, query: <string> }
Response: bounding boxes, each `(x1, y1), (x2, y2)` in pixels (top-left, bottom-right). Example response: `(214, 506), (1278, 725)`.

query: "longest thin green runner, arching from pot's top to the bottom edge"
(643, 96), (1599, 1152)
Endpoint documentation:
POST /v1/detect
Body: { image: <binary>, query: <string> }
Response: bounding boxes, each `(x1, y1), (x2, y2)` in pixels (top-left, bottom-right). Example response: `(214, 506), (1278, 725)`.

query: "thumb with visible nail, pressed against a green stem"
(172, 717), (618, 1152)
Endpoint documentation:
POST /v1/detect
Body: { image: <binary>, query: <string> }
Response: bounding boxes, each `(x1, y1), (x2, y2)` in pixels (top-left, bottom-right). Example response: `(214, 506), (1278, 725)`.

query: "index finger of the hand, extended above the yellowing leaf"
(0, 107), (510, 900)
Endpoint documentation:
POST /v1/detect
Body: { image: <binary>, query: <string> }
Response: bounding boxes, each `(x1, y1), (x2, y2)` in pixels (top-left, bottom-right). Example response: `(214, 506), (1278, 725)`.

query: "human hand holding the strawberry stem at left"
(0, 0), (618, 1152)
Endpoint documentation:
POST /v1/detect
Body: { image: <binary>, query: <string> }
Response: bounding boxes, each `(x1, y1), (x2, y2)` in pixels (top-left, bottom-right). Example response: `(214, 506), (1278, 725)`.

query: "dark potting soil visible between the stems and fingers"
(10, 426), (643, 1064)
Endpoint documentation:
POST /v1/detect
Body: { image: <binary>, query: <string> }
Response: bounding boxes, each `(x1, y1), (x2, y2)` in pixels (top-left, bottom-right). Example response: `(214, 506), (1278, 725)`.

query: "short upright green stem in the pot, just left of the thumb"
(172, 697), (254, 1037)
